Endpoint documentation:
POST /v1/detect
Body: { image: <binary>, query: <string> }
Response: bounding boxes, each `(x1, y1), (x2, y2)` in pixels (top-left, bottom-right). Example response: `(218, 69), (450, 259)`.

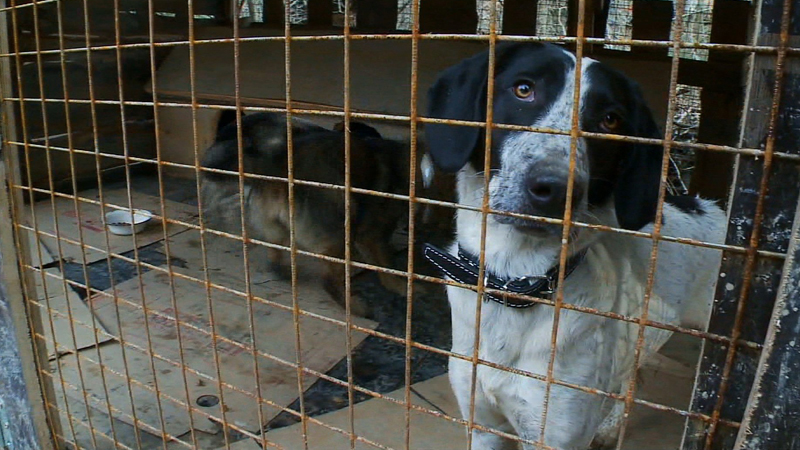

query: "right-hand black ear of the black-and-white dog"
(614, 92), (664, 230)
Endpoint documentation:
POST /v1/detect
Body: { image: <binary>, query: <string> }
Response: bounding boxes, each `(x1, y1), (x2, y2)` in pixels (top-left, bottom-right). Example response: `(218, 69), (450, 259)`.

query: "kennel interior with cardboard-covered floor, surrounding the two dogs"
(0, 0), (800, 449)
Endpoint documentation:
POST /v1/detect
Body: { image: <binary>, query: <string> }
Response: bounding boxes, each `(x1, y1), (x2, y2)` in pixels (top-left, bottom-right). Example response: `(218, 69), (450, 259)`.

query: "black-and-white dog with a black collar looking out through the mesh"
(425, 43), (726, 449)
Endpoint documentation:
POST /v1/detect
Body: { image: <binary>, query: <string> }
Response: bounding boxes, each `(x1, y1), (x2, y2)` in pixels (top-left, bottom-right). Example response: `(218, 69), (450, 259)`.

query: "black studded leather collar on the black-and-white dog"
(422, 244), (586, 308)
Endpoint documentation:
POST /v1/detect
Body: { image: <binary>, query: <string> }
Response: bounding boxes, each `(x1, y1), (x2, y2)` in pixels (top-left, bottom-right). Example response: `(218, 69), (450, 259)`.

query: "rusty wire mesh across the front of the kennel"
(0, 0), (800, 448)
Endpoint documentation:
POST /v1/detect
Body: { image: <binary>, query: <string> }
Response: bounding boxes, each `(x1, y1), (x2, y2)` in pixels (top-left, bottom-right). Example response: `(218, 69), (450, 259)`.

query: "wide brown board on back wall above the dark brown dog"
(150, 28), (485, 115)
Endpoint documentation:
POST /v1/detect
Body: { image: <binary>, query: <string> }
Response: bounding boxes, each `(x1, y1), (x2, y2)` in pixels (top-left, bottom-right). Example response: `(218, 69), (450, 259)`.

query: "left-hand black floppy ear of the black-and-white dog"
(425, 52), (489, 172)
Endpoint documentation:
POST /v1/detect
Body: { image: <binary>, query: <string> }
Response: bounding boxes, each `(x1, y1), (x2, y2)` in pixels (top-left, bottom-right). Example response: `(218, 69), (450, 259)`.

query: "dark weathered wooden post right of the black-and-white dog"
(683, 0), (800, 450)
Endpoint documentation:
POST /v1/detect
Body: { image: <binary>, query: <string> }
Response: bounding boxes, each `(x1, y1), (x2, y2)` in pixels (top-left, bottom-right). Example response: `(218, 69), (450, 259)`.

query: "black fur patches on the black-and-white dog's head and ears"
(426, 43), (663, 229)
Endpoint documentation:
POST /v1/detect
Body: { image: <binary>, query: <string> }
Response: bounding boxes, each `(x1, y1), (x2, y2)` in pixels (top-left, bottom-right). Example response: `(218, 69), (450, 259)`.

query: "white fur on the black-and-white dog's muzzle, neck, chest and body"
(447, 51), (725, 450)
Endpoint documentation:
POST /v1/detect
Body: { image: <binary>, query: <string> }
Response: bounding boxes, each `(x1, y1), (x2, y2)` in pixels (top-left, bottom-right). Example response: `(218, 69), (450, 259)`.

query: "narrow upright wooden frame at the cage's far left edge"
(0, 0), (61, 449)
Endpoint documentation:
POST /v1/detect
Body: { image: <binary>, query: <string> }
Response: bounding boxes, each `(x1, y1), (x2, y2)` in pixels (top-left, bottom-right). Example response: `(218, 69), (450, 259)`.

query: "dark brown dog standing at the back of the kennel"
(202, 113), (424, 315)
